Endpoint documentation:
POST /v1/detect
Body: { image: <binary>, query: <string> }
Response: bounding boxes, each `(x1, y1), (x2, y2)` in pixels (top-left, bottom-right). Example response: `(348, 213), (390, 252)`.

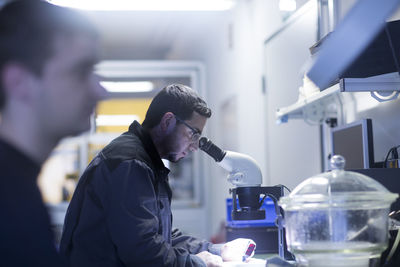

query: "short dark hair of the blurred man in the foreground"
(0, 0), (97, 108)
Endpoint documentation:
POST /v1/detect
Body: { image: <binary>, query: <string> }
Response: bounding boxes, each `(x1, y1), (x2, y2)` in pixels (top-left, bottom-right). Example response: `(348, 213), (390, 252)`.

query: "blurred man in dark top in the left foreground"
(0, 1), (105, 267)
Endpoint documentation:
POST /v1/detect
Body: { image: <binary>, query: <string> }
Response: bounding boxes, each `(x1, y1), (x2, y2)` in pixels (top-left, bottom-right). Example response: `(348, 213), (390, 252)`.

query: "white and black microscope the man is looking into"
(199, 137), (293, 260)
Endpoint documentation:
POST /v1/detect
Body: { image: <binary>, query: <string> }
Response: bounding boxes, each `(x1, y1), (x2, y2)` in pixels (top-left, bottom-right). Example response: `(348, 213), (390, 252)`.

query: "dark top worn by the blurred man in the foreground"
(0, 139), (64, 267)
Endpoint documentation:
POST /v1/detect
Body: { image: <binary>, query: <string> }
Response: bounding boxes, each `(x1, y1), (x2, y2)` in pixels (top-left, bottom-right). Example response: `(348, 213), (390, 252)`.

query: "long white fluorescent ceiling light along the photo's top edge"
(47, 0), (234, 11)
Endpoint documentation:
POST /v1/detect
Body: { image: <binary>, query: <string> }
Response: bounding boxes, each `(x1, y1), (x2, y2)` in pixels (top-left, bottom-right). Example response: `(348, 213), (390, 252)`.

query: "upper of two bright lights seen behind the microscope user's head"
(100, 81), (154, 93)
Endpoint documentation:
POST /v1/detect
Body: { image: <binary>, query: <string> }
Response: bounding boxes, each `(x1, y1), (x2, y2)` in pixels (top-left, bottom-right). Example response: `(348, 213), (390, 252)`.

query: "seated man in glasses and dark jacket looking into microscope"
(61, 84), (253, 267)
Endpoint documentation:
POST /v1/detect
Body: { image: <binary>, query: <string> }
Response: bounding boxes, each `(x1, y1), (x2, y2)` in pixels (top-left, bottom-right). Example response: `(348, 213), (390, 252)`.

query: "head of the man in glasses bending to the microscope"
(142, 84), (211, 162)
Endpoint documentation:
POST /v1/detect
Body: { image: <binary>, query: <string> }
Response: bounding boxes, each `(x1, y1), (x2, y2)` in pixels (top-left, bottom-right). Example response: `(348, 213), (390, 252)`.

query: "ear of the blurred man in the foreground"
(1, 63), (33, 102)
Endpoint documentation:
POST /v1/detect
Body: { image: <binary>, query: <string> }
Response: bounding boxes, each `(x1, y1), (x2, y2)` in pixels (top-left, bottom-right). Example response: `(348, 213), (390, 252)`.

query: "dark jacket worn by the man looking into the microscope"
(60, 121), (216, 267)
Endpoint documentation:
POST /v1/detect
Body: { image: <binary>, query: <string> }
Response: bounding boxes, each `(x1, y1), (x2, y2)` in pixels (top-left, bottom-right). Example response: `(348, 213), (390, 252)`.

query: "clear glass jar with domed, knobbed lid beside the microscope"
(279, 155), (398, 267)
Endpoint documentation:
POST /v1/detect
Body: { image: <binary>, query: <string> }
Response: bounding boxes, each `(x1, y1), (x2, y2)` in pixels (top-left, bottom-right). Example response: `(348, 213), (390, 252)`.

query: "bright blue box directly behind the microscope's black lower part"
(226, 197), (276, 228)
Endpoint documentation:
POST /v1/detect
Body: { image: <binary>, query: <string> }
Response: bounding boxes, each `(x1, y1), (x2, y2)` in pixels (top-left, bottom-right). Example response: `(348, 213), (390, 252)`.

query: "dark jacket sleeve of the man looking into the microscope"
(102, 160), (205, 267)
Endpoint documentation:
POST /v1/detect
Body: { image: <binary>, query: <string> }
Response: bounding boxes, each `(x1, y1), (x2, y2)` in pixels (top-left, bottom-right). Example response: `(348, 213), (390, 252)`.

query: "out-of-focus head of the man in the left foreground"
(0, 0), (105, 138)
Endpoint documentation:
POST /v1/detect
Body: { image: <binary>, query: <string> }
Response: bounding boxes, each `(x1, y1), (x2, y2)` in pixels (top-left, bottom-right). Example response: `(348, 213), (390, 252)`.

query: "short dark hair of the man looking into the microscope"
(142, 84), (211, 129)
